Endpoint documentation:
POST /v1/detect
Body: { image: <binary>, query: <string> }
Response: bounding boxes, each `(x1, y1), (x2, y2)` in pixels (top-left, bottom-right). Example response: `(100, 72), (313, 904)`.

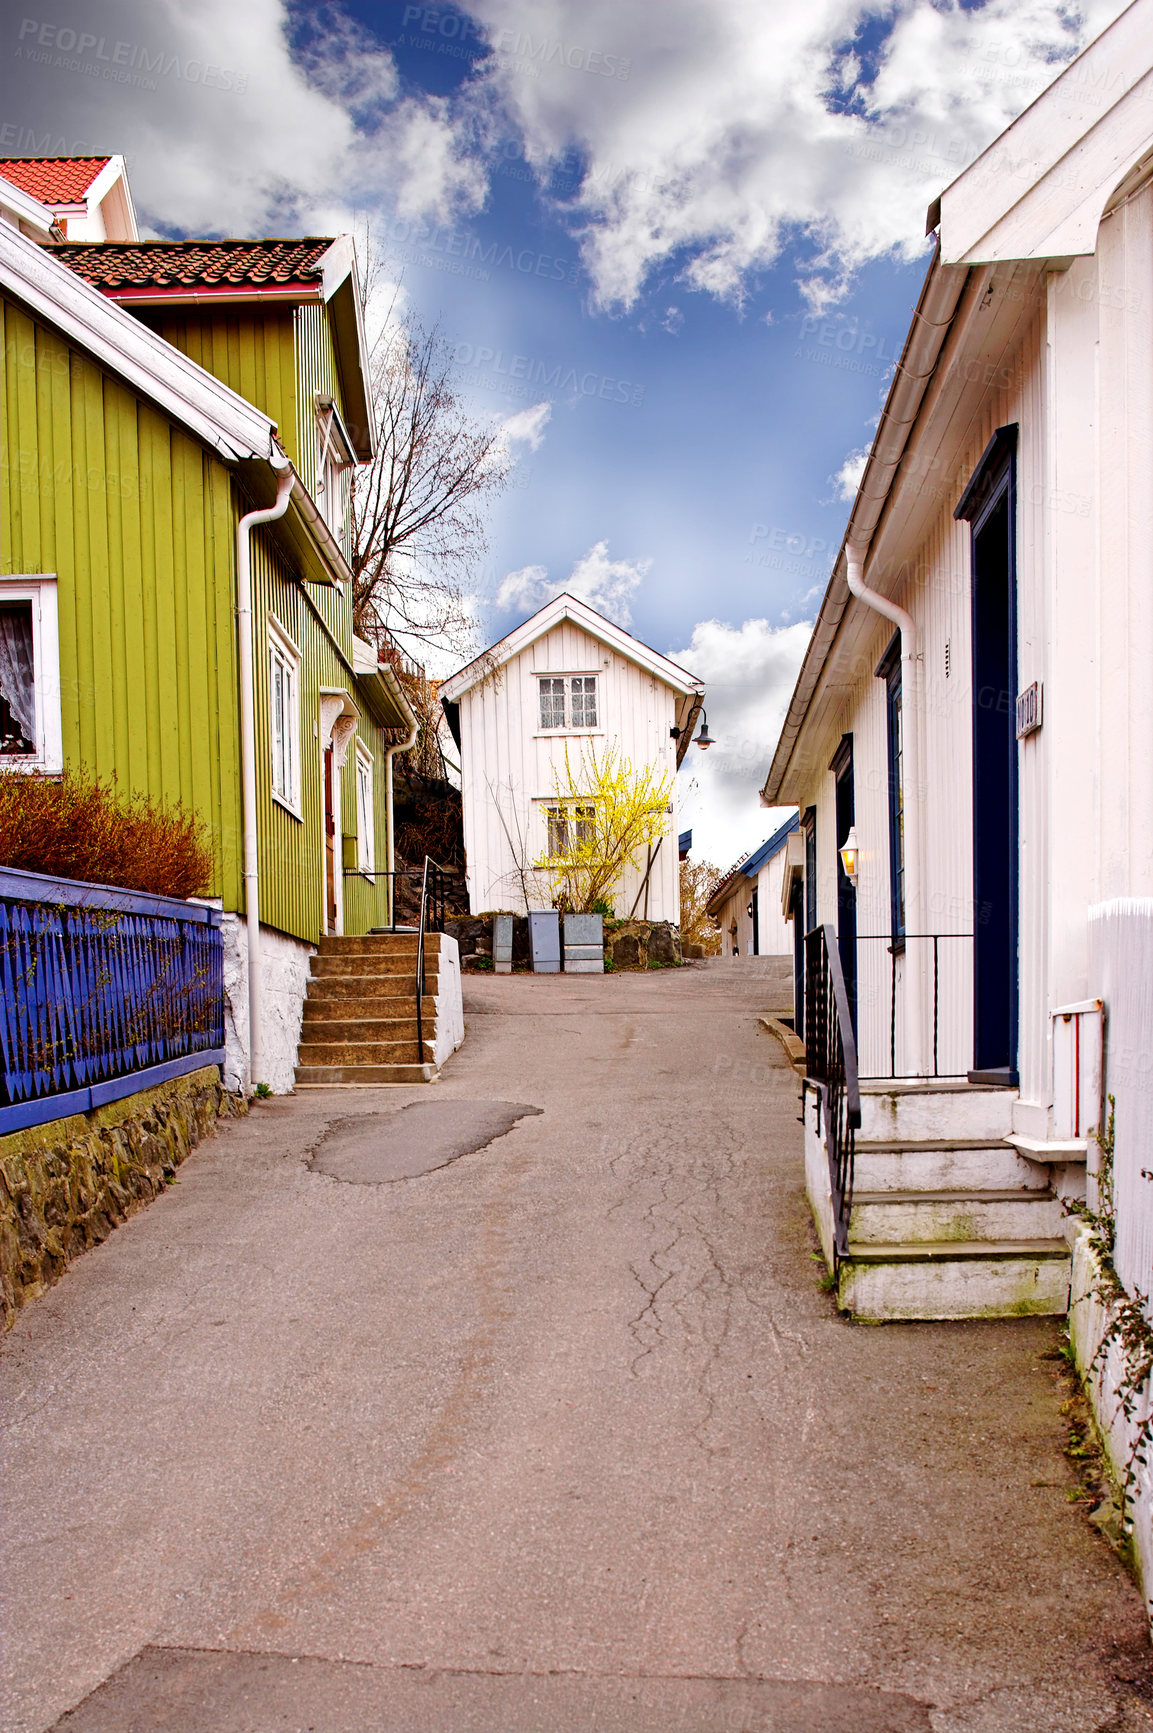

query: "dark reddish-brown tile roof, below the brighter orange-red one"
(52, 236), (333, 295)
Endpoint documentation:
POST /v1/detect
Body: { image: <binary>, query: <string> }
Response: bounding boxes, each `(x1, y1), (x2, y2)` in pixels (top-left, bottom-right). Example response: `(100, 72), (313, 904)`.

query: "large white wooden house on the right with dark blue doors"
(763, 0), (1153, 1317)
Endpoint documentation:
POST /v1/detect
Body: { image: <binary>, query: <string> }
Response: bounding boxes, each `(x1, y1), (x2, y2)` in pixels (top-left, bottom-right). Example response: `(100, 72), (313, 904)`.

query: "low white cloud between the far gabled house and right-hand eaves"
(673, 620), (811, 867)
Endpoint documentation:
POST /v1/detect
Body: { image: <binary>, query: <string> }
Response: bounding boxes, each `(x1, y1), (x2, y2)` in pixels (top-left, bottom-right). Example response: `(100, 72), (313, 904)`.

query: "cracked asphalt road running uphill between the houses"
(0, 960), (1153, 1733)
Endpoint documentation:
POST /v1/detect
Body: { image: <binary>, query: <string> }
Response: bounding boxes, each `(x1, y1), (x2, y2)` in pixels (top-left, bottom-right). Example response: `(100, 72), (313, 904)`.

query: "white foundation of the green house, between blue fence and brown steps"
(220, 915), (312, 1095)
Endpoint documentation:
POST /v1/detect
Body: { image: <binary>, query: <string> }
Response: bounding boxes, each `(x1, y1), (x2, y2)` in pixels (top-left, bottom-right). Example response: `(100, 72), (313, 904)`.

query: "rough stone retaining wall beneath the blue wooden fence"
(0, 1066), (246, 1329)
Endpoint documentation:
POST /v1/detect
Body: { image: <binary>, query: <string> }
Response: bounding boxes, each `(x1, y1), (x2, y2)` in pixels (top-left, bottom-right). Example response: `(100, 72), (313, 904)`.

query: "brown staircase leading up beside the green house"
(296, 932), (440, 1088)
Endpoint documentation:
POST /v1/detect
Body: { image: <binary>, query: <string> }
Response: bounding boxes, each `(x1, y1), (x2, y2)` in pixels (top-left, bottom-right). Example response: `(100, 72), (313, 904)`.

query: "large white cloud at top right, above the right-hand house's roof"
(470, 0), (1122, 307)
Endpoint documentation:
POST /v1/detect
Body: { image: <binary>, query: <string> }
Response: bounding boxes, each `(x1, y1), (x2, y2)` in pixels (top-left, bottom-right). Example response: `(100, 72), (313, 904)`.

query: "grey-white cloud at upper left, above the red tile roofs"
(5, 0), (487, 234)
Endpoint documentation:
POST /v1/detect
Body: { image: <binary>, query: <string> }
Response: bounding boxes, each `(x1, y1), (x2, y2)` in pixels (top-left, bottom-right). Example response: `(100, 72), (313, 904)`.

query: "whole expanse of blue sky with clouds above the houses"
(0, 0), (1122, 865)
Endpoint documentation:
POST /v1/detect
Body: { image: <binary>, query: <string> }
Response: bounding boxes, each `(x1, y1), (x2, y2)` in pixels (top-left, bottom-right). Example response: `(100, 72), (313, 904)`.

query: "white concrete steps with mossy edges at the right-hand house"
(818, 1083), (1072, 1319)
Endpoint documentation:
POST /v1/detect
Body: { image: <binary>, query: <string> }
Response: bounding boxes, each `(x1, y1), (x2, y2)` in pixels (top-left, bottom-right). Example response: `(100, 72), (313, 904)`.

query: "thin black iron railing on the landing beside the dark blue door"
(857, 932), (973, 1081)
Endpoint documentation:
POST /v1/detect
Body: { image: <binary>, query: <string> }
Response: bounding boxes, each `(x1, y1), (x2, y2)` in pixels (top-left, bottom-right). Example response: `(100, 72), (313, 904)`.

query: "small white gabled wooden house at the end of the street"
(440, 594), (704, 922)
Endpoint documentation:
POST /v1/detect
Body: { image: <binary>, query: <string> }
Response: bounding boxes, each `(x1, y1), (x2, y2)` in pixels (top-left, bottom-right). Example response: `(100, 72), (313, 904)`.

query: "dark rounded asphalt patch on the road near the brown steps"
(309, 1099), (544, 1185)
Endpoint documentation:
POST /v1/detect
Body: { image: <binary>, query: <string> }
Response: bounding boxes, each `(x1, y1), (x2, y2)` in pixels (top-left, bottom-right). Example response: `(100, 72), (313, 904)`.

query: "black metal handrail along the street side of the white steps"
(804, 924), (860, 1267)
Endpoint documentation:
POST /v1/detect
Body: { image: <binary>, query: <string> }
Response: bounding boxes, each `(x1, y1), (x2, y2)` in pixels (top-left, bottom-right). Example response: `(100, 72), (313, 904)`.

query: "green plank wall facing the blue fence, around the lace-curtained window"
(0, 298), (241, 908)
